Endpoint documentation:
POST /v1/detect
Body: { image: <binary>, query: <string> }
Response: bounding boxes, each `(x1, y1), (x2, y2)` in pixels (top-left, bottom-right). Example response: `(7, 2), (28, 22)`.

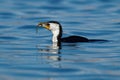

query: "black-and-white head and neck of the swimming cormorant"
(38, 21), (62, 46)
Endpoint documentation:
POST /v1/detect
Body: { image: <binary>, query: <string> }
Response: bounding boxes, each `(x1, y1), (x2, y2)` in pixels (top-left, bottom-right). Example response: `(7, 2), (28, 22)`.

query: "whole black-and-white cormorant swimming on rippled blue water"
(38, 21), (107, 45)
